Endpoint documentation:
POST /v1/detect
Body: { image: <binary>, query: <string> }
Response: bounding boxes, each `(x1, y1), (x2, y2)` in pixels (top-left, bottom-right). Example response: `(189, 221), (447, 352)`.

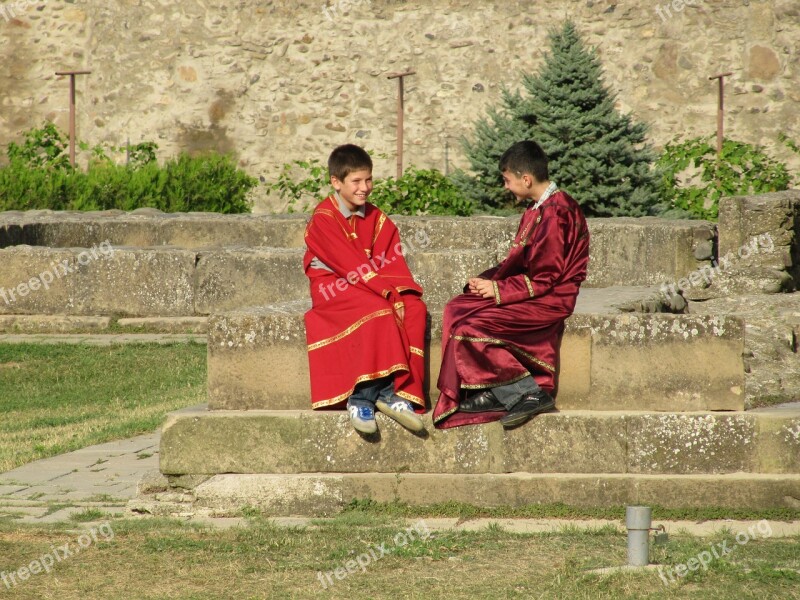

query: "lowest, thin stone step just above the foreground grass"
(178, 473), (800, 516)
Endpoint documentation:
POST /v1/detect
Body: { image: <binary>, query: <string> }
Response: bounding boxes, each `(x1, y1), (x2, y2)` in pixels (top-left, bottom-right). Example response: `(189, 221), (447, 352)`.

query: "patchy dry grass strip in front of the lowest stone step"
(0, 511), (800, 600)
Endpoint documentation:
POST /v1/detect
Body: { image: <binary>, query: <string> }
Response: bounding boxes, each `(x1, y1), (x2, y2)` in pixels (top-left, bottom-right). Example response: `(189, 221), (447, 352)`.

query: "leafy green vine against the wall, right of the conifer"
(658, 136), (792, 220)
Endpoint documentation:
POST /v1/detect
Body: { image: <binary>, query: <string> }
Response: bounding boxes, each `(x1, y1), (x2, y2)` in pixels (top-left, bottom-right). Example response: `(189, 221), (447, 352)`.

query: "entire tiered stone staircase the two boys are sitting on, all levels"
(0, 192), (800, 515)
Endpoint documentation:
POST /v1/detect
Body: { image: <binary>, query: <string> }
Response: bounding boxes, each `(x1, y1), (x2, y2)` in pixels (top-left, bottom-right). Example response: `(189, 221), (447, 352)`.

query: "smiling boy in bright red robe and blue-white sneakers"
(303, 144), (427, 434)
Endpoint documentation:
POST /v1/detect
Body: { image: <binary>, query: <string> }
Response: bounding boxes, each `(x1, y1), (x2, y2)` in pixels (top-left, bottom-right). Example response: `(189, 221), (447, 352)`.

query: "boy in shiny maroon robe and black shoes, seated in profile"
(433, 141), (589, 428)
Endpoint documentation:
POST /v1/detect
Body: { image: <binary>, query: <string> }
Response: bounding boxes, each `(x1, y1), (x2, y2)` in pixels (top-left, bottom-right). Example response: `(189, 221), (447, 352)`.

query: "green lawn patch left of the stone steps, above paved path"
(0, 343), (206, 473)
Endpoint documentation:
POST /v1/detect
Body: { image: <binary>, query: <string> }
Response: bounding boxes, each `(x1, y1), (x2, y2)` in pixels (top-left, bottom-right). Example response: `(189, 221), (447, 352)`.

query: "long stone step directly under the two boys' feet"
(159, 405), (800, 478)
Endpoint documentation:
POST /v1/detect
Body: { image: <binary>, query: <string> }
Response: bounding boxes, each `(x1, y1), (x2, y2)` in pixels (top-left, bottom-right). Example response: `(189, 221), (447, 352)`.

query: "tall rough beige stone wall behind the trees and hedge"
(0, 0), (800, 209)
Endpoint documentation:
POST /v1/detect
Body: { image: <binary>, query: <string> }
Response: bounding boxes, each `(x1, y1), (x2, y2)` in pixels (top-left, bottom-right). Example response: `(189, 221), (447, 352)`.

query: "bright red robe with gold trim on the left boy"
(303, 196), (427, 410)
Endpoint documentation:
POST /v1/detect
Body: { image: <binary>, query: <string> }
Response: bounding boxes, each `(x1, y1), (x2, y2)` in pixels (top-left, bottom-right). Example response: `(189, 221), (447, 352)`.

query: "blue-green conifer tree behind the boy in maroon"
(458, 21), (659, 216)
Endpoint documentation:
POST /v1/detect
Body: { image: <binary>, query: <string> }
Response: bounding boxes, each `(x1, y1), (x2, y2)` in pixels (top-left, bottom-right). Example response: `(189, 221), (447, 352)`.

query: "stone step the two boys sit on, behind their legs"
(208, 300), (745, 411)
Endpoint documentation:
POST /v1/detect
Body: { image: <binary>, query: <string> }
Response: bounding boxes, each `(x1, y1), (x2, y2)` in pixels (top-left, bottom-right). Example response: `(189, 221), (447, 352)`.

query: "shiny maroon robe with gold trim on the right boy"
(433, 191), (589, 429)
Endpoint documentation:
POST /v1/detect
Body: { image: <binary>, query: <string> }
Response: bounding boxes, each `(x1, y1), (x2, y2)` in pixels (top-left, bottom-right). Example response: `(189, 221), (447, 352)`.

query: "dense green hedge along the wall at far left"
(0, 123), (257, 213)
